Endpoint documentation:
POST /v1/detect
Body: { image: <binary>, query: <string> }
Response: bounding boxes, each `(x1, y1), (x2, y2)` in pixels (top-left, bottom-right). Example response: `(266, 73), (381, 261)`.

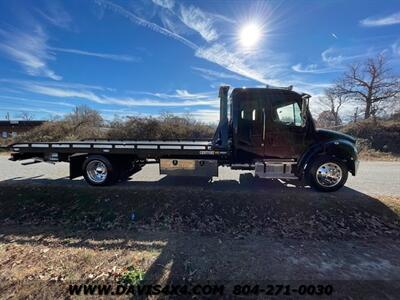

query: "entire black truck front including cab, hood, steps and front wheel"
(220, 88), (358, 191)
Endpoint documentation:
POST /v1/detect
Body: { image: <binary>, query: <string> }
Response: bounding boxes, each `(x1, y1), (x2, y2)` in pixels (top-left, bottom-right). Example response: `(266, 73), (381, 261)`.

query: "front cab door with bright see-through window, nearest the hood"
(265, 99), (306, 158)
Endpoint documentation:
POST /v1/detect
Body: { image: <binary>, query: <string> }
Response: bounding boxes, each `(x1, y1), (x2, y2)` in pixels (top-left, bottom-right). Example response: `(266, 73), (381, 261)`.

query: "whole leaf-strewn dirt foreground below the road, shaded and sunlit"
(0, 185), (400, 299)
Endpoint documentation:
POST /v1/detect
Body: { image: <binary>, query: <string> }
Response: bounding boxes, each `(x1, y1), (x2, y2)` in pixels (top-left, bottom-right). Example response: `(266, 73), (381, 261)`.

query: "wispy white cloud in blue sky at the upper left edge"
(0, 26), (62, 80)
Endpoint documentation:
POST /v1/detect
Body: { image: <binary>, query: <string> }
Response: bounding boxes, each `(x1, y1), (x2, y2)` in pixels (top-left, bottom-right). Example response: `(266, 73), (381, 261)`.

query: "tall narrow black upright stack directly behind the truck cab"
(213, 86), (229, 148)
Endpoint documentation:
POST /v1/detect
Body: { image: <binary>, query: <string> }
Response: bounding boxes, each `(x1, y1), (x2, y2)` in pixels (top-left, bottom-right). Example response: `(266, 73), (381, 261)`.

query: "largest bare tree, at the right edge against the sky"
(334, 54), (400, 119)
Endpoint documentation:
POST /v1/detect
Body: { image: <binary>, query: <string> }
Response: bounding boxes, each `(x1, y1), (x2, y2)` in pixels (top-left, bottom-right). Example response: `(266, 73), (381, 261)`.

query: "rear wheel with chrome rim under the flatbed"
(82, 155), (118, 186)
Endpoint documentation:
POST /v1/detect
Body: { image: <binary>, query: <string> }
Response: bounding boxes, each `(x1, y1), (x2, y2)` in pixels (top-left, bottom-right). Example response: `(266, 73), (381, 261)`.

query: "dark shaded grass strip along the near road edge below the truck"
(0, 185), (398, 238)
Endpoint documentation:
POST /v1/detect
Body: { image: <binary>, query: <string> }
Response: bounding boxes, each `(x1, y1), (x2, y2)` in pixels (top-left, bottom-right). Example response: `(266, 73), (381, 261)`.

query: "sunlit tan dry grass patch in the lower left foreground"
(0, 228), (159, 282)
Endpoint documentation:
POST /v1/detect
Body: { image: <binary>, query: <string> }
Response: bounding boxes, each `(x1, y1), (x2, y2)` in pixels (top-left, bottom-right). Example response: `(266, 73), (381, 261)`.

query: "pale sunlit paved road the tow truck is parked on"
(0, 155), (400, 196)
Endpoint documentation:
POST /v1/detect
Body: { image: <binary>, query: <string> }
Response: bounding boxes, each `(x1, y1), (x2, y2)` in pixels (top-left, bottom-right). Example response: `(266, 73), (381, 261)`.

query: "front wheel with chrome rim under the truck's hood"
(306, 156), (348, 192)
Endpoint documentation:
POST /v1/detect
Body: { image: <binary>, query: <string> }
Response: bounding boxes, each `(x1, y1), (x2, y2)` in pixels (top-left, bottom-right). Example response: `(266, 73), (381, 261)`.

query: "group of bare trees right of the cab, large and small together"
(317, 54), (400, 127)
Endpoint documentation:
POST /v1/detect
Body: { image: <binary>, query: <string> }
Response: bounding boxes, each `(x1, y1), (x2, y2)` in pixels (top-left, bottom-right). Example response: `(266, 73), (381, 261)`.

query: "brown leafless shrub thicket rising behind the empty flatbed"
(15, 106), (215, 142)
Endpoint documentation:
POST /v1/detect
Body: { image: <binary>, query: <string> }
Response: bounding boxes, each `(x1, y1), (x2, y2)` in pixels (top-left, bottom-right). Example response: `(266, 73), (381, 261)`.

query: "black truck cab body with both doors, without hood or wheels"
(230, 88), (315, 162)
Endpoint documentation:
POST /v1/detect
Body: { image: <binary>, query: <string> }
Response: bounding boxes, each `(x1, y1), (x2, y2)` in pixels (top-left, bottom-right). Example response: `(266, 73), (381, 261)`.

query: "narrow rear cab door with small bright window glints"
(237, 92), (264, 157)
